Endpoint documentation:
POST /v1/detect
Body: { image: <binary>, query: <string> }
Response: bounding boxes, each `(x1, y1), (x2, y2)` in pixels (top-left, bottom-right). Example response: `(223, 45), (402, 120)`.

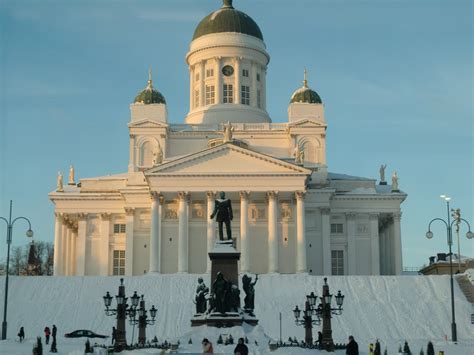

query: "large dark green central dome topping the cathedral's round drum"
(193, 0), (263, 41)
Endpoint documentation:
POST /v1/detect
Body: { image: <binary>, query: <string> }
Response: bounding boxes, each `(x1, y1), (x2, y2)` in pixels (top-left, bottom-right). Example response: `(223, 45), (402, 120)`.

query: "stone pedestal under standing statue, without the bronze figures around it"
(191, 240), (258, 327)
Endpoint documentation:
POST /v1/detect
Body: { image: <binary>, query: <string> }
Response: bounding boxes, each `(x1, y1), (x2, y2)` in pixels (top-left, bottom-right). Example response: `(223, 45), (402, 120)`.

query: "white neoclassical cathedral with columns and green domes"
(49, 0), (407, 276)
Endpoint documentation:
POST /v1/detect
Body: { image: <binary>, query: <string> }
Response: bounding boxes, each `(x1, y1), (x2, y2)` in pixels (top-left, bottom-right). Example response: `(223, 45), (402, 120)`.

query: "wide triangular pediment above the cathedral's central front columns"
(145, 143), (311, 176)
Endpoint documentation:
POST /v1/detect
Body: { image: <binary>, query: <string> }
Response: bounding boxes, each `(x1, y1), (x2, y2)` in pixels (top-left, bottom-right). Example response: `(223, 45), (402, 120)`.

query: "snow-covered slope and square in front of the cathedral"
(0, 275), (474, 355)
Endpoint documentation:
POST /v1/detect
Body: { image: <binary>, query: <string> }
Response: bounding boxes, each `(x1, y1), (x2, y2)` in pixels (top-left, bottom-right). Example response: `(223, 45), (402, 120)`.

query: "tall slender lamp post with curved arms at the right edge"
(426, 195), (474, 342)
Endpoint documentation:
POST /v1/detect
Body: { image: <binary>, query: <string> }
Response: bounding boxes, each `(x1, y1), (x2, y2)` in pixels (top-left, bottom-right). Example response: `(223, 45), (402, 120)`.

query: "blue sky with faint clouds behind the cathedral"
(0, 0), (474, 267)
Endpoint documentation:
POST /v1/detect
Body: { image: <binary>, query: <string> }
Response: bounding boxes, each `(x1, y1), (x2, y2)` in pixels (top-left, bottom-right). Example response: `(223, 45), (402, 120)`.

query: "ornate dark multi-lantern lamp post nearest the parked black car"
(103, 279), (140, 352)
